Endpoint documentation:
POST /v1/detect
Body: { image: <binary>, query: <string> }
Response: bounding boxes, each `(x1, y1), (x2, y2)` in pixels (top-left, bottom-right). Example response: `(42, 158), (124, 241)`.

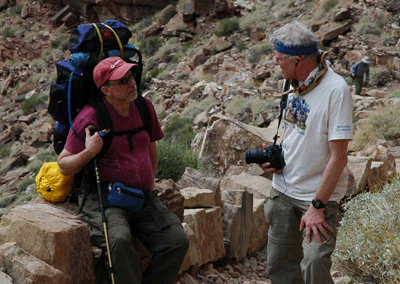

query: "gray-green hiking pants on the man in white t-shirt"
(264, 188), (339, 284)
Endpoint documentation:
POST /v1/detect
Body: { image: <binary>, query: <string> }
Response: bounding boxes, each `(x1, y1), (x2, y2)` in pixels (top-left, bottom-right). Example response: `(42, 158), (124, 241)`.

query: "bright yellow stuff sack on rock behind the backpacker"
(35, 162), (74, 203)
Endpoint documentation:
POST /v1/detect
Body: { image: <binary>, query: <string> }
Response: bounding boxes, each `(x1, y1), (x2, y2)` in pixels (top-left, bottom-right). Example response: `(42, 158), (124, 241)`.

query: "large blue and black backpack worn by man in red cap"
(48, 20), (151, 154)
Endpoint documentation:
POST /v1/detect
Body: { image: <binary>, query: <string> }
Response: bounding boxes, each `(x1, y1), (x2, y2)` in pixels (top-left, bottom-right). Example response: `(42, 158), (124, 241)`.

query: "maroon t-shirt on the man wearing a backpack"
(64, 96), (164, 190)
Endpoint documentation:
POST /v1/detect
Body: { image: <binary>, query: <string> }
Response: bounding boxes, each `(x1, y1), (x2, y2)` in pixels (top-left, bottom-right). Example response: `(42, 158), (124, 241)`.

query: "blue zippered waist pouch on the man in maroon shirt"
(107, 182), (144, 213)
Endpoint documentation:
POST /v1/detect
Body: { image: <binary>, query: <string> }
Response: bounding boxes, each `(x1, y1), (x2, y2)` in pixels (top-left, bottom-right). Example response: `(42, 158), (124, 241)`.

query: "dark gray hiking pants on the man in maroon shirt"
(79, 189), (189, 284)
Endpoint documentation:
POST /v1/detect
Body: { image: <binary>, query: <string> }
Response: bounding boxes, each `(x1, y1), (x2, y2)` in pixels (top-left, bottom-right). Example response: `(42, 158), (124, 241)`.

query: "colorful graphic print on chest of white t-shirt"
(284, 96), (310, 135)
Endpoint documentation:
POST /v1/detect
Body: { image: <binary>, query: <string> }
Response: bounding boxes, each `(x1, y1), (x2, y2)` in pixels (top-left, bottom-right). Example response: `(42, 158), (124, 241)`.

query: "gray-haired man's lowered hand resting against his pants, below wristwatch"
(300, 205), (334, 243)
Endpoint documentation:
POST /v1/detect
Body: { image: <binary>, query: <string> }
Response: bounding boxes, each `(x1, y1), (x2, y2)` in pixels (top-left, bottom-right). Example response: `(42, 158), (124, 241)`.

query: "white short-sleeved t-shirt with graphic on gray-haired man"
(272, 68), (353, 201)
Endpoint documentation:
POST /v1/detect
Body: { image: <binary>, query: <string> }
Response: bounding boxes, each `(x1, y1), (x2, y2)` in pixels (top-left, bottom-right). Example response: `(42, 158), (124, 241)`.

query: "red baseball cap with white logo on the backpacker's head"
(93, 57), (137, 88)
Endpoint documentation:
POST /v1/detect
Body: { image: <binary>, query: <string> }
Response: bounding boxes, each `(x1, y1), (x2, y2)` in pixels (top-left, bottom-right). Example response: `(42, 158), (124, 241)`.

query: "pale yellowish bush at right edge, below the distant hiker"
(353, 104), (400, 150)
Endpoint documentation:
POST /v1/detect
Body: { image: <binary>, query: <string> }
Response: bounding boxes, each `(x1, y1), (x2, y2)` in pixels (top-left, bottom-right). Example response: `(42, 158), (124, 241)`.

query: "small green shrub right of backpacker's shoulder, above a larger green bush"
(163, 115), (196, 146)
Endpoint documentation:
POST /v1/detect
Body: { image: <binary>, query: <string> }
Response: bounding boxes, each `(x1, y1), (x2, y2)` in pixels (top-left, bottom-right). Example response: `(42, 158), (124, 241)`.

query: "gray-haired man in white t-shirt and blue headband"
(261, 22), (353, 284)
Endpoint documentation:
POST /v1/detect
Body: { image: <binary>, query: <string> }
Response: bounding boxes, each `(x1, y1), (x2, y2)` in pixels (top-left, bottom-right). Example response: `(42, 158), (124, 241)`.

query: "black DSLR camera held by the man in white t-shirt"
(246, 144), (286, 170)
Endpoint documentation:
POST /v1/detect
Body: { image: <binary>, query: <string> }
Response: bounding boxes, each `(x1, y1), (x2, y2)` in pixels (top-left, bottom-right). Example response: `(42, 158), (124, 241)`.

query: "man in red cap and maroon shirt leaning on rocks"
(58, 57), (189, 284)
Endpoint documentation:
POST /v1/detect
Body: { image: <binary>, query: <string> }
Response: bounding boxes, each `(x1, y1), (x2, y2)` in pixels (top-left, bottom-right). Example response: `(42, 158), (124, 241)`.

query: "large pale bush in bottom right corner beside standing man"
(332, 177), (400, 284)
